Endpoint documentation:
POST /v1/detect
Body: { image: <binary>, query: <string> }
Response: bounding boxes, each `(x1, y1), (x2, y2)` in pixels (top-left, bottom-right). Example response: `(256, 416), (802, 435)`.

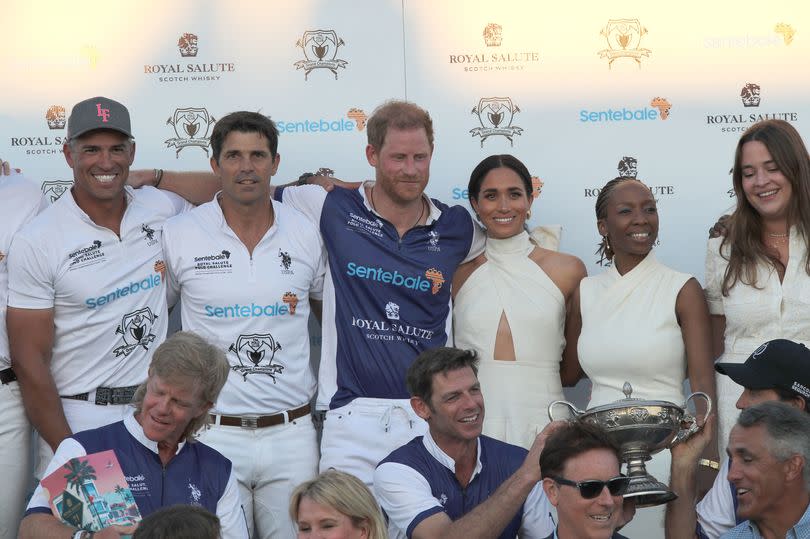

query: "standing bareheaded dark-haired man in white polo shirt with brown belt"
(163, 111), (325, 538)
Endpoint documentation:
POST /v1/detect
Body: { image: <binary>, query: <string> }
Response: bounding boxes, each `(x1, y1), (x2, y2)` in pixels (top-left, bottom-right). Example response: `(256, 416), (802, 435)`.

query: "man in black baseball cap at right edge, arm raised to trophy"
(666, 339), (810, 539)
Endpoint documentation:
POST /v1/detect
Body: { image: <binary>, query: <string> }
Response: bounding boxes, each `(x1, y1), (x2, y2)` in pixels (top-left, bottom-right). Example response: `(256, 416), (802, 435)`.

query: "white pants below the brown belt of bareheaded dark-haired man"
(199, 415), (318, 539)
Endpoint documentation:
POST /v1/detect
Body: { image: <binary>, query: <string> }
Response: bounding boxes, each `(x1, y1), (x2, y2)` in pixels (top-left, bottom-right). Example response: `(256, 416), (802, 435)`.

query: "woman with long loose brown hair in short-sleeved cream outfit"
(706, 120), (810, 454)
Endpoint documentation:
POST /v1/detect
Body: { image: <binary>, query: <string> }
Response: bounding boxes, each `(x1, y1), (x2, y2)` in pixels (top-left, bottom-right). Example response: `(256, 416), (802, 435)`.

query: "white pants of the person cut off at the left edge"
(0, 382), (34, 539)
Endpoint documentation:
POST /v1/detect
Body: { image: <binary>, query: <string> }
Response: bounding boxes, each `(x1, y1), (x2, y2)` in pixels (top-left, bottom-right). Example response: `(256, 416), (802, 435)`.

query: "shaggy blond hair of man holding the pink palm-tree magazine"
(132, 331), (231, 442)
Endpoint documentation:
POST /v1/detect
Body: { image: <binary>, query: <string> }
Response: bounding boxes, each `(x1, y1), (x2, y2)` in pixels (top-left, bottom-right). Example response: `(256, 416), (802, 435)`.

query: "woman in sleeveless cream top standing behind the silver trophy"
(574, 177), (717, 538)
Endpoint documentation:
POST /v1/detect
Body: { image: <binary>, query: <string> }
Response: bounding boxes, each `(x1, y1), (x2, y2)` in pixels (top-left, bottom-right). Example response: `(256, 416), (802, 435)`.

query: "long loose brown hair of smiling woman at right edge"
(720, 120), (810, 296)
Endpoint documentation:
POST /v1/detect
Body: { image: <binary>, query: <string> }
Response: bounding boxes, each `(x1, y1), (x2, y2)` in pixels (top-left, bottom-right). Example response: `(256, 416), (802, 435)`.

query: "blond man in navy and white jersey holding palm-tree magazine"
(20, 332), (248, 539)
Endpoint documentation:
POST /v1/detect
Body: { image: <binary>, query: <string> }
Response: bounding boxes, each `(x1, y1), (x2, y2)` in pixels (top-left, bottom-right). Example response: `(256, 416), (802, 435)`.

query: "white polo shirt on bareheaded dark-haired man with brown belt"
(163, 197), (325, 415)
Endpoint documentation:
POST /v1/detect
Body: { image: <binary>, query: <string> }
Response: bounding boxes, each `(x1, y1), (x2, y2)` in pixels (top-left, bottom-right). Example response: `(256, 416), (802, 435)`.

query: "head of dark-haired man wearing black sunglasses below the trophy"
(540, 422), (630, 539)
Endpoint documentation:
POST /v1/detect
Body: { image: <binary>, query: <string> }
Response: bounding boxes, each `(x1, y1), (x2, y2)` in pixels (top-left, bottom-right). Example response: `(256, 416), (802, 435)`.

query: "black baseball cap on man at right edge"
(714, 339), (810, 400)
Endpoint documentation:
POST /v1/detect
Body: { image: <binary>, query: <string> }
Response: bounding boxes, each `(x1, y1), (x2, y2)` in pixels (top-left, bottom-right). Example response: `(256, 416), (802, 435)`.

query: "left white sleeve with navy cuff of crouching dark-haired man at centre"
(374, 462), (444, 537)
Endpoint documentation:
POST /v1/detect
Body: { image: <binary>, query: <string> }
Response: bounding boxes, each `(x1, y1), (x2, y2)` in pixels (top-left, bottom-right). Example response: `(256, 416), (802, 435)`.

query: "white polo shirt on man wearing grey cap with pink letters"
(8, 187), (192, 395)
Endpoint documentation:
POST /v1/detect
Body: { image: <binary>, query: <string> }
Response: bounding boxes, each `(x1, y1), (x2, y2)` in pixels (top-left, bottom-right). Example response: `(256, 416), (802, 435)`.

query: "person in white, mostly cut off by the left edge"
(0, 166), (45, 539)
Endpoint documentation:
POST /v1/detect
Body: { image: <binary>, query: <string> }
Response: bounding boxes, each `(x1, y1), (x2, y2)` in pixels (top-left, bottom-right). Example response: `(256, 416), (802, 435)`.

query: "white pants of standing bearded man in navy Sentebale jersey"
(320, 397), (427, 488)
